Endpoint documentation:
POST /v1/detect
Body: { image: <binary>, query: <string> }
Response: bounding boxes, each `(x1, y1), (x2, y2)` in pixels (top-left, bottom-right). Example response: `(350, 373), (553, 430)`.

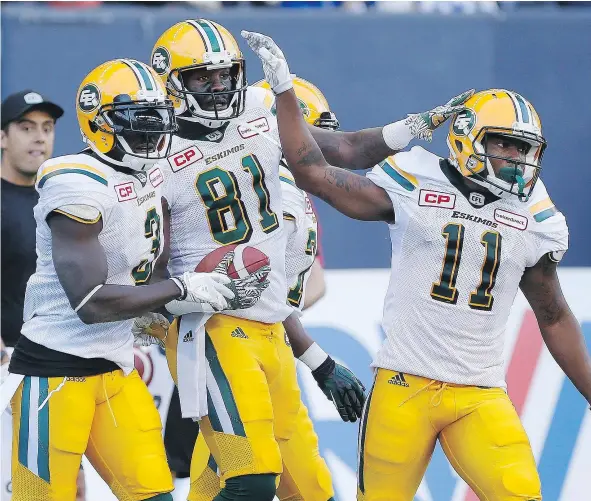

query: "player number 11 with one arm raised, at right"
(243, 32), (591, 501)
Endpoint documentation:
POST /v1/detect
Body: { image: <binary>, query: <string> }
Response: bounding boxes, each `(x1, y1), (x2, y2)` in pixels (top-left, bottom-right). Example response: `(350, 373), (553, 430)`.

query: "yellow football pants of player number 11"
(357, 369), (542, 501)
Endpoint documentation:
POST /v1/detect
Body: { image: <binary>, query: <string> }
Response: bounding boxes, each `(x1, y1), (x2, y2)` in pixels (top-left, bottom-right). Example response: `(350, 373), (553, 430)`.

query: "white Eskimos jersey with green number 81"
(165, 88), (291, 323)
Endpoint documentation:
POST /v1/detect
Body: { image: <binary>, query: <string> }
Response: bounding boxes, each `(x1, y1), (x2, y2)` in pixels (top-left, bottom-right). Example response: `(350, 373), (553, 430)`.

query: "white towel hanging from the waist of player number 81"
(176, 313), (212, 421)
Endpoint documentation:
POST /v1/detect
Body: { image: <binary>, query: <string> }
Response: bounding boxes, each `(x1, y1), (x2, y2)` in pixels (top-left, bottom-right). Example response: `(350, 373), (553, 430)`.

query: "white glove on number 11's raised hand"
(240, 30), (293, 95)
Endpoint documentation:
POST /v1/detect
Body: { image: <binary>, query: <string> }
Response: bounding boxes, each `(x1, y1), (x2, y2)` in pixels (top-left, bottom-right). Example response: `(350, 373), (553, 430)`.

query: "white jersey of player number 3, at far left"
(22, 154), (164, 372)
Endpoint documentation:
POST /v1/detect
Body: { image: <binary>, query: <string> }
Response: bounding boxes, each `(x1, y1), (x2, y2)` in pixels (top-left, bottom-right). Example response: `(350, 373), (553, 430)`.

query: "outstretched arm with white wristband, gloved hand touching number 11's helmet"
(308, 89), (474, 170)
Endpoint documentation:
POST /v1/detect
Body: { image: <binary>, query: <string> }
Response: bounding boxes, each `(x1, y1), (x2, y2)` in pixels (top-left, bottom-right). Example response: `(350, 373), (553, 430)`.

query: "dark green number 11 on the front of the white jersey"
(431, 223), (502, 311)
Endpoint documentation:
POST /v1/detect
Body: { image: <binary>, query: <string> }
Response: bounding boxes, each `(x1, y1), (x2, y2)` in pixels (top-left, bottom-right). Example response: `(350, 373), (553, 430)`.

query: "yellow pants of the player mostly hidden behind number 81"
(188, 396), (334, 501)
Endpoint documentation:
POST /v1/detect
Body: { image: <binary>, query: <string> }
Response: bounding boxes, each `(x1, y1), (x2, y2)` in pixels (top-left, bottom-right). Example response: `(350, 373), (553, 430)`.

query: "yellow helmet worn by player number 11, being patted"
(447, 89), (546, 201)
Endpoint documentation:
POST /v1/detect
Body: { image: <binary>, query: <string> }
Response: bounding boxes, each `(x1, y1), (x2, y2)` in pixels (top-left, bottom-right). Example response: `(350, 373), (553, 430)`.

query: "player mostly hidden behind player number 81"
(183, 77), (346, 501)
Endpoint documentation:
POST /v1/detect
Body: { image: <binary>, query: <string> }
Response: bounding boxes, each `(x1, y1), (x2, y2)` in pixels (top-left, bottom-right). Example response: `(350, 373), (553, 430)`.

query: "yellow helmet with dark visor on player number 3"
(76, 59), (176, 170)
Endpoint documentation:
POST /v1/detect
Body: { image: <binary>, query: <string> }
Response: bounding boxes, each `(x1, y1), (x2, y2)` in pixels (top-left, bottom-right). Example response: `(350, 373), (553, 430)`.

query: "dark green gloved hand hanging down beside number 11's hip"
(312, 357), (365, 423)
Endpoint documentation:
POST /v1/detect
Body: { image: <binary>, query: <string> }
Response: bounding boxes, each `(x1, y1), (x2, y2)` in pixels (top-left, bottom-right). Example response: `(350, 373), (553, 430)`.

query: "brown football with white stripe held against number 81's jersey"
(195, 244), (270, 282)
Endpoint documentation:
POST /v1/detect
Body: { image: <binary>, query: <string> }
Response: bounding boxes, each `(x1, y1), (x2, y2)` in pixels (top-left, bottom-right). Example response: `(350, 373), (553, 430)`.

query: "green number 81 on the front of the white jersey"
(195, 155), (279, 245)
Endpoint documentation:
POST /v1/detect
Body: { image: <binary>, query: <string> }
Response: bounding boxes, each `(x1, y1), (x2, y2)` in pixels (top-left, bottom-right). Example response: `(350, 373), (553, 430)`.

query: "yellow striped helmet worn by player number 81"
(151, 19), (247, 128)
